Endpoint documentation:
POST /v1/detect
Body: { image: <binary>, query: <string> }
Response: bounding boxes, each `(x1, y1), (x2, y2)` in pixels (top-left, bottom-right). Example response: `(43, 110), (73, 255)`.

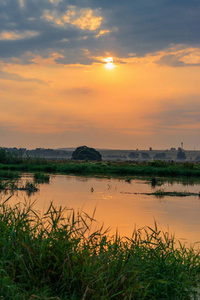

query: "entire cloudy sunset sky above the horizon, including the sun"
(0, 0), (200, 150)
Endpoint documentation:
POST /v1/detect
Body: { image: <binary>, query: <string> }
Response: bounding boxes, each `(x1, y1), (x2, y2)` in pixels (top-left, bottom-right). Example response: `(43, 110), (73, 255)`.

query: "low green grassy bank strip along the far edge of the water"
(0, 159), (200, 177)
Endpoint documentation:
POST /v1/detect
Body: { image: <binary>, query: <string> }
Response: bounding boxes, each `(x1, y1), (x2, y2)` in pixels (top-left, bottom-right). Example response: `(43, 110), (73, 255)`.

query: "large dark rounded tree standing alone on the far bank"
(72, 146), (102, 161)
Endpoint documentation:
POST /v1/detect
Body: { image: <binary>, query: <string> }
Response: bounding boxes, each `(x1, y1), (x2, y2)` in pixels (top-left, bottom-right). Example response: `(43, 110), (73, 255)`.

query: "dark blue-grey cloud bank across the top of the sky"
(0, 0), (200, 66)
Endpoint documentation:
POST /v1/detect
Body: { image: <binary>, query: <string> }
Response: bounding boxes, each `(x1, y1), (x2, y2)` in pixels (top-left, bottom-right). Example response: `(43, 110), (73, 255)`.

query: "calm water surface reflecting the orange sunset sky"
(4, 174), (200, 243)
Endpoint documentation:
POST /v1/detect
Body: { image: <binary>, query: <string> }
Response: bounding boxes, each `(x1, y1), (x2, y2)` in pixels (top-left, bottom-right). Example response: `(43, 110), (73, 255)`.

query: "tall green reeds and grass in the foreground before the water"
(0, 199), (200, 300)
